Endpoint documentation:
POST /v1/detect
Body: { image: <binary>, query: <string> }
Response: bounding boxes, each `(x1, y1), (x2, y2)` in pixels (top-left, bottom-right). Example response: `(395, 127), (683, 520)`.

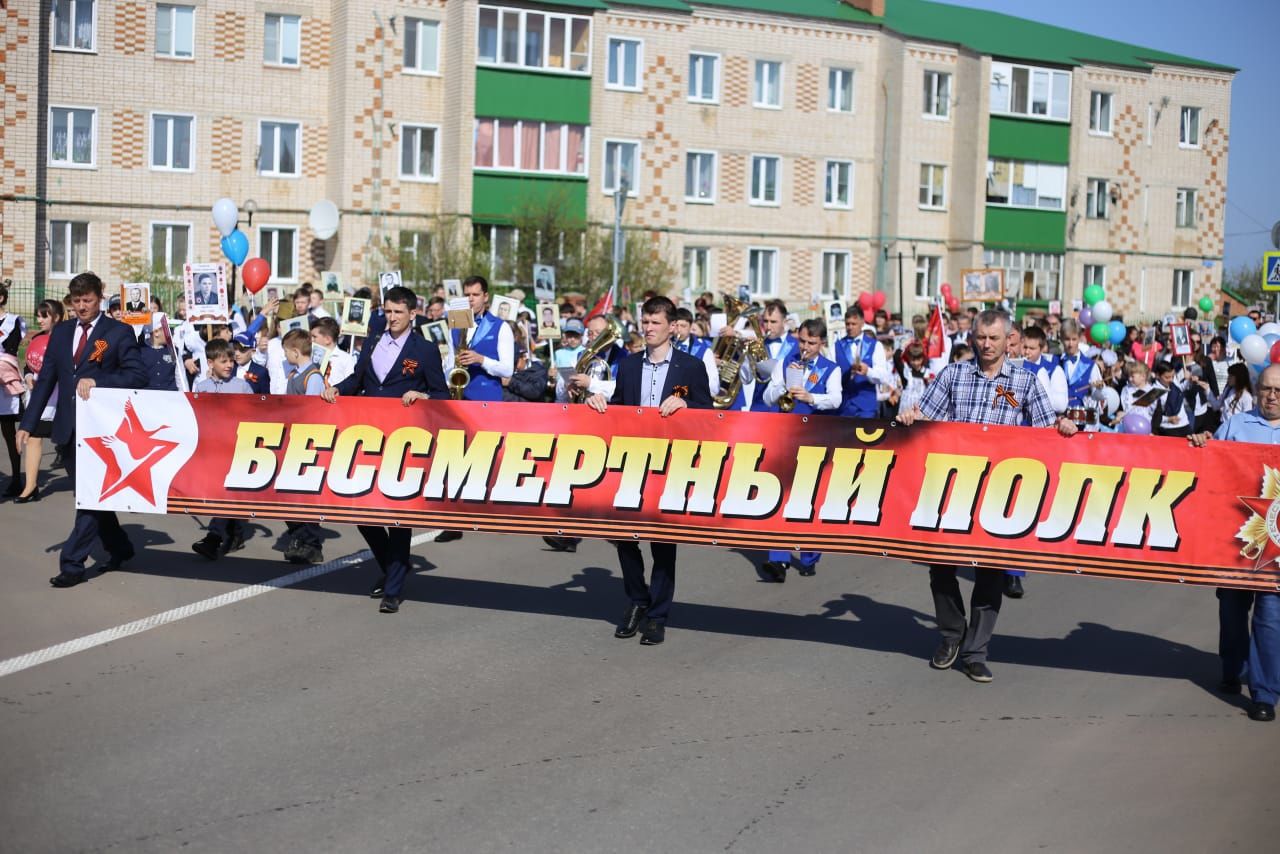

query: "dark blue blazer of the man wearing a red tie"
(22, 315), (147, 444)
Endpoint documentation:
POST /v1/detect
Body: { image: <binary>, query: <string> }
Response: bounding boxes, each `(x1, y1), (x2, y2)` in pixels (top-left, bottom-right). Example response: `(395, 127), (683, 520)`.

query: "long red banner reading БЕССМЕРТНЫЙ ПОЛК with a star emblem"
(77, 389), (1280, 590)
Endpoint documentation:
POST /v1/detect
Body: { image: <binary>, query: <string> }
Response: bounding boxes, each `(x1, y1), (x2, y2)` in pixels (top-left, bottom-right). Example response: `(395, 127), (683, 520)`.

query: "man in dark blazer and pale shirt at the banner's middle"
(586, 297), (712, 647)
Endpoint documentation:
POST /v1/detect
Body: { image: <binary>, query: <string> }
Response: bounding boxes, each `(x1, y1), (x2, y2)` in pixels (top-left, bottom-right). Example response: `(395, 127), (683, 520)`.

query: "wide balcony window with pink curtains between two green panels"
(475, 119), (588, 175)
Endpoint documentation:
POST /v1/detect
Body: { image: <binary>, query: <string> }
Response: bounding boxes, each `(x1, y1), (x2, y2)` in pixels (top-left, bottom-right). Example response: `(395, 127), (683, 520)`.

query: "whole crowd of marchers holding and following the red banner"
(0, 273), (1280, 721)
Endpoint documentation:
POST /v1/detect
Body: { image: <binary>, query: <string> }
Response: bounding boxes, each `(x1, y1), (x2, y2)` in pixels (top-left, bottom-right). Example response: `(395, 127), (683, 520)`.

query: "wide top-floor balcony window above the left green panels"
(476, 6), (591, 74)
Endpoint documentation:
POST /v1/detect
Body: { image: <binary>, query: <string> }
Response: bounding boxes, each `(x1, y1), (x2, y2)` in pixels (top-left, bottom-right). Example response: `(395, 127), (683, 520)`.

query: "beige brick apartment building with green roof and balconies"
(0, 0), (1234, 318)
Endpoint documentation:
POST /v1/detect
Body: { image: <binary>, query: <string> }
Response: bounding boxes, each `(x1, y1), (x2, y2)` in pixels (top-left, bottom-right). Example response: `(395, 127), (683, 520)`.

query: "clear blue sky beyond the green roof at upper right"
(947, 0), (1280, 269)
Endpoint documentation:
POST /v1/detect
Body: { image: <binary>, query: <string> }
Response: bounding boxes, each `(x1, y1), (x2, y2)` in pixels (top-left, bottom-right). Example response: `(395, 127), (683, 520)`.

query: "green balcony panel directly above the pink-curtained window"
(476, 68), (591, 124)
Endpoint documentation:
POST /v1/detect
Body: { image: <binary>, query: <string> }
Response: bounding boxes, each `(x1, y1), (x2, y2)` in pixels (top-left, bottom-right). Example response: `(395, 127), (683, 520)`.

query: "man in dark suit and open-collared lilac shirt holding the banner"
(321, 287), (449, 613)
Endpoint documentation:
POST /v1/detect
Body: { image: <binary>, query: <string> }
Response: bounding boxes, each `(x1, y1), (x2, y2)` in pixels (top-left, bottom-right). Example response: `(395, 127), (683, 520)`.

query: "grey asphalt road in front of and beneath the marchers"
(0, 468), (1280, 854)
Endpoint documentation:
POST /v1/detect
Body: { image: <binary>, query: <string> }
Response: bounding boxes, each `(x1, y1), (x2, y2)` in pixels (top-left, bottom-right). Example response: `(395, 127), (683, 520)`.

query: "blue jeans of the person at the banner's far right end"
(1217, 588), (1280, 705)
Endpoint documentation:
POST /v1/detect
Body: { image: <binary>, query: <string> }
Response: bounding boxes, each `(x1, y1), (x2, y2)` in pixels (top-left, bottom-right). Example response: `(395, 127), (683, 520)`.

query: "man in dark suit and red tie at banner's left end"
(18, 273), (147, 588)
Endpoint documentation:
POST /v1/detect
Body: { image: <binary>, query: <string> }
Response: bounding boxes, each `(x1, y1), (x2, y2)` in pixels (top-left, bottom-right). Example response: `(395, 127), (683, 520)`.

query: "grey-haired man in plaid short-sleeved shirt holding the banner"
(897, 311), (1076, 682)
